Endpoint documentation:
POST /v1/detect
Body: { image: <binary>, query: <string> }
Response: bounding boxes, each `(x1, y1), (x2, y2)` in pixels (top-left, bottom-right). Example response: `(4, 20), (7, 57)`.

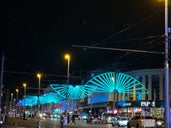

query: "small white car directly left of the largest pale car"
(112, 116), (128, 127)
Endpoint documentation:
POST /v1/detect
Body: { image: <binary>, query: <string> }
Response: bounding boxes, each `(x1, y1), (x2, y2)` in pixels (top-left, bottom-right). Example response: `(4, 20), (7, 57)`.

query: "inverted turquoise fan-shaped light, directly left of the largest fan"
(50, 84), (95, 99)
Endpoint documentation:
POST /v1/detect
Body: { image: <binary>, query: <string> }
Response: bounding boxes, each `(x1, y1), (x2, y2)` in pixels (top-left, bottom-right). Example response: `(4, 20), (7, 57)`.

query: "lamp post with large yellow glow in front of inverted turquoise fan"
(64, 54), (71, 123)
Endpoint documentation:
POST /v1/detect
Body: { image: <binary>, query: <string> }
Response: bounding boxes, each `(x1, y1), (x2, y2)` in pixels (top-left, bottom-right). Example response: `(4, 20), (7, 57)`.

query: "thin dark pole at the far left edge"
(0, 54), (4, 126)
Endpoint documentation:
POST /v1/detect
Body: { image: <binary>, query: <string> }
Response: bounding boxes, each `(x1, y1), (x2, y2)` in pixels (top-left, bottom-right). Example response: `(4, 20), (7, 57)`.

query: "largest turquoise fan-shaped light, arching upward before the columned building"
(85, 72), (149, 94)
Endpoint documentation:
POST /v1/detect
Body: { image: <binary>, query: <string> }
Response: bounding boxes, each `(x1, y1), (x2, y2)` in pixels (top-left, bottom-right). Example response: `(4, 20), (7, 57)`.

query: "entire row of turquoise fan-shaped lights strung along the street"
(16, 72), (149, 106)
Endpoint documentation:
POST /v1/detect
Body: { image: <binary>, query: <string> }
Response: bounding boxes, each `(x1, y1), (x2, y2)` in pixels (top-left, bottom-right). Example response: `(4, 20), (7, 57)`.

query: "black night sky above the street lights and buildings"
(4, 0), (171, 95)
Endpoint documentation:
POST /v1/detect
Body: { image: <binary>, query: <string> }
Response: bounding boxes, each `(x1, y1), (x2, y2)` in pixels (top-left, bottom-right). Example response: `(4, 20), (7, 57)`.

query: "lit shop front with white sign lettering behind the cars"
(115, 100), (164, 118)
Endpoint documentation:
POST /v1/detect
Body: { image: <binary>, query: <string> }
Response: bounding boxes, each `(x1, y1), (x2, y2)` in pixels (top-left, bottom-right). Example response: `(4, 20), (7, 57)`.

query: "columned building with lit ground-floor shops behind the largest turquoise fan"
(78, 69), (171, 118)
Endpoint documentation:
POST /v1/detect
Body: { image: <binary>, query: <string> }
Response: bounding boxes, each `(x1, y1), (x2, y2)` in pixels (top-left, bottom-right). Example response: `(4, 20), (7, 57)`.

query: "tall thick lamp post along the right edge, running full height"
(164, 0), (170, 128)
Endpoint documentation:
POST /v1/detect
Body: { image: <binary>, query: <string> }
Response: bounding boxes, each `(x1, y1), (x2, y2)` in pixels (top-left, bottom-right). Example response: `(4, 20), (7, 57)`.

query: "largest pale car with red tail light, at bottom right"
(127, 116), (156, 128)
